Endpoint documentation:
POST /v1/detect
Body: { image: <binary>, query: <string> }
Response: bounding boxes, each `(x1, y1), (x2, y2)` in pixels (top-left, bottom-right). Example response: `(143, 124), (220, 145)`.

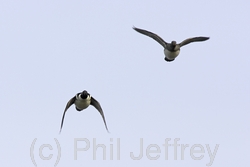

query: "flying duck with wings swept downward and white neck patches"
(60, 90), (109, 133)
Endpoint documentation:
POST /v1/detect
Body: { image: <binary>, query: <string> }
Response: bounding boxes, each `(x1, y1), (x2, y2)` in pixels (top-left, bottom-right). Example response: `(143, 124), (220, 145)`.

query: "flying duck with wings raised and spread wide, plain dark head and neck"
(133, 27), (209, 62)
